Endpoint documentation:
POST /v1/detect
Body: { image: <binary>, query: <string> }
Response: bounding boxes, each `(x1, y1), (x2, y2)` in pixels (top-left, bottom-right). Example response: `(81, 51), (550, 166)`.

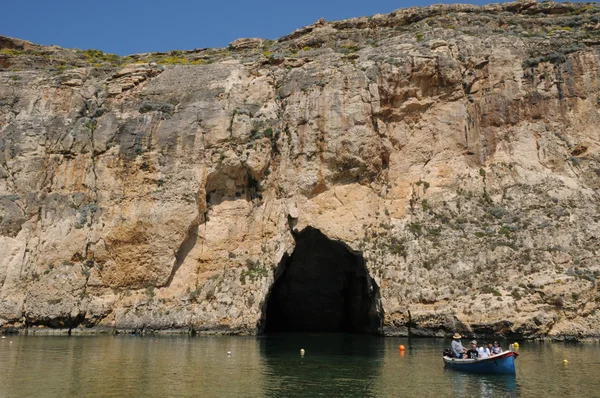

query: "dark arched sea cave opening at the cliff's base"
(261, 227), (383, 334)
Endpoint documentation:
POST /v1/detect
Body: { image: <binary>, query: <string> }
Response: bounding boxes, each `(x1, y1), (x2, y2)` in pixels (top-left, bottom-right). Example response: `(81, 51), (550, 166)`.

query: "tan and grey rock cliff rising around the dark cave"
(0, 2), (600, 339)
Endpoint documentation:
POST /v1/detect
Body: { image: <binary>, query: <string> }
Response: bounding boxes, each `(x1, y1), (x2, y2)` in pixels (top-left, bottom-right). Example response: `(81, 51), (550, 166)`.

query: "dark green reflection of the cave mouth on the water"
(259, 334), (384, 397)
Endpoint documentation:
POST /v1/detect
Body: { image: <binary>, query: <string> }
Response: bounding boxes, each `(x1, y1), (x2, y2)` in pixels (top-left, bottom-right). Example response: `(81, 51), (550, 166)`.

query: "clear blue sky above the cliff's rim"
(0, 0), (556, 55)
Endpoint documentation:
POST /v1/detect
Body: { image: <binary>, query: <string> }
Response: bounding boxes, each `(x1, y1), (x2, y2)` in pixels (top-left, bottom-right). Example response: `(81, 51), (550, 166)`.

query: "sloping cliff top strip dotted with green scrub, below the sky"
(0, 0), (600, 72)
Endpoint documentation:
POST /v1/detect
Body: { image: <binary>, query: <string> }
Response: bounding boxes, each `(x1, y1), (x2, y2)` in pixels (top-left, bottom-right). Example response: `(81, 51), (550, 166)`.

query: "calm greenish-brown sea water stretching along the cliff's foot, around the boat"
(0, 334), (600, 397)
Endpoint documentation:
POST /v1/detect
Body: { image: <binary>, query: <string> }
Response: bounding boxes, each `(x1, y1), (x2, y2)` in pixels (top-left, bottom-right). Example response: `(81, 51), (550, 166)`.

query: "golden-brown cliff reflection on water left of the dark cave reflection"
(0, 336), (264, 397)
